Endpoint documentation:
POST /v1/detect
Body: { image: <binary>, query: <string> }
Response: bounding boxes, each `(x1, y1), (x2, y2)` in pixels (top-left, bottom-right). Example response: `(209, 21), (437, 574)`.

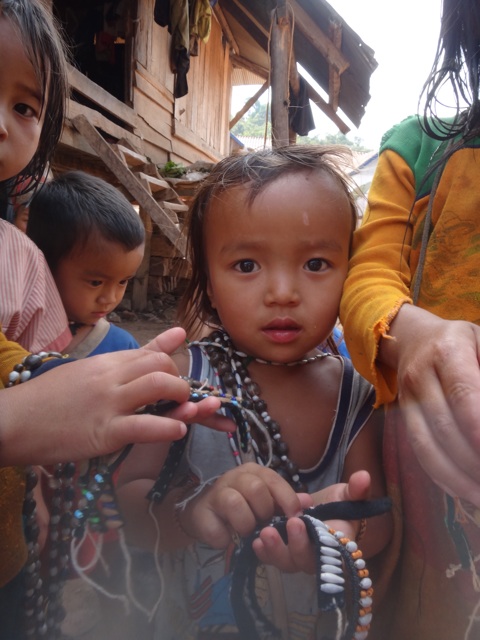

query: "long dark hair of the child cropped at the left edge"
(0, 0), (68, 192)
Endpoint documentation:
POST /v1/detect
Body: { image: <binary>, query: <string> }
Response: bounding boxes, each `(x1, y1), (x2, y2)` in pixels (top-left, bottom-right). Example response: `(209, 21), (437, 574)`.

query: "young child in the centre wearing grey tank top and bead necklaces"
(119, 146), (391, 640)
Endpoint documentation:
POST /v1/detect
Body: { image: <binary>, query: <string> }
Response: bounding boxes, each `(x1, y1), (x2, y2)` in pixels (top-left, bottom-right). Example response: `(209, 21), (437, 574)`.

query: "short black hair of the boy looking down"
(27, 171), (145, 272)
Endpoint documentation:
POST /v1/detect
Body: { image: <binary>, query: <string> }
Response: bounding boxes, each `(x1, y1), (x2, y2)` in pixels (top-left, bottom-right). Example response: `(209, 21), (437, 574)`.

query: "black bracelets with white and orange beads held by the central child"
(230, 498), (391, 640)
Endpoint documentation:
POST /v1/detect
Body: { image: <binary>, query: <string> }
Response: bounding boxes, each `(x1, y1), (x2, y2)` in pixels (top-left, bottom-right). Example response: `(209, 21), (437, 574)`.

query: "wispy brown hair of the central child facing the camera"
(178, 145), (357, 333)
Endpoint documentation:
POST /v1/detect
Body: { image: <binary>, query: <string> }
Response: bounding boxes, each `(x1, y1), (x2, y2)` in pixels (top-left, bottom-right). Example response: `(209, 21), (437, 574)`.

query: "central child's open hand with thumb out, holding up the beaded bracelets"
(252, 471), (370, 573)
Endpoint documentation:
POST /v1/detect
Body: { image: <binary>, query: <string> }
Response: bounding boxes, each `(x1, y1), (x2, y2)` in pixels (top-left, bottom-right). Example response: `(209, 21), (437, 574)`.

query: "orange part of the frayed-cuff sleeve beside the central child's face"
(340, 150), (415, 405)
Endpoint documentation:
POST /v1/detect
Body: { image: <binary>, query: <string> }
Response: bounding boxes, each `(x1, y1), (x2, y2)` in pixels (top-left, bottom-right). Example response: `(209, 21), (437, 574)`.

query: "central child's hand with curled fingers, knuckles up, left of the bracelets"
(177, 463), (313, 549)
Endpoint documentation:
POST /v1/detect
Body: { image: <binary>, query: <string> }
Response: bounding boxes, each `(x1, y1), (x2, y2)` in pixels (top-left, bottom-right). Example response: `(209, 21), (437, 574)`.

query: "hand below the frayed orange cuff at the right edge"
(379, 304), (480, 507)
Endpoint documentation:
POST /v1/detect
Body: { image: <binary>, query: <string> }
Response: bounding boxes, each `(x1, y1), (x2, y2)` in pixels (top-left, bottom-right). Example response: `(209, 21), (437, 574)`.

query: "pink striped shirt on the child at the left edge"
(0, 220), (72, 353)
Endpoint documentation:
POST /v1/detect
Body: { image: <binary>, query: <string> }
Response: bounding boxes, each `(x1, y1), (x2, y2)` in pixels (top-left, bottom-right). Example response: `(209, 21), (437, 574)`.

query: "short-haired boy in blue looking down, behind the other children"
(27, 171), (145, 358)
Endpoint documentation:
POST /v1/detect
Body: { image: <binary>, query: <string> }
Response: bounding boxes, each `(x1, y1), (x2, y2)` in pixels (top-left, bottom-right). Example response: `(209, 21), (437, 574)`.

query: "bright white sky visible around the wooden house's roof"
(232, 0), (441, 149)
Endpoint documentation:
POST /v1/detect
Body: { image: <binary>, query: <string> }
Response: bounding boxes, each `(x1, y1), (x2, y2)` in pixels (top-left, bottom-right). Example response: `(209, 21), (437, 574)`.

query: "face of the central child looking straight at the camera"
(204, 172), (352, 362)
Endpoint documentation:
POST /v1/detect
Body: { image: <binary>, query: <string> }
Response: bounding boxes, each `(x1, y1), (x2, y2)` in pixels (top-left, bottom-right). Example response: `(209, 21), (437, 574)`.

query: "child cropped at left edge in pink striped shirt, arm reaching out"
(0, 0), (226, 640)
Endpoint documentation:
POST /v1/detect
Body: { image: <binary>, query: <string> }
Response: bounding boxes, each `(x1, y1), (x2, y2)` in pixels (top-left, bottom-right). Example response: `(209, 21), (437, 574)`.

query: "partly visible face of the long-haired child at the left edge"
(0, 16), (43, 181)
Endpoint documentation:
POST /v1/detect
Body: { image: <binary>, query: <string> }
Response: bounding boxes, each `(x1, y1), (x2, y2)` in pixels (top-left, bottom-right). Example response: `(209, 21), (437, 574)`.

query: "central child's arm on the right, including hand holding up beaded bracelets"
(253, 411), (392, 573)
